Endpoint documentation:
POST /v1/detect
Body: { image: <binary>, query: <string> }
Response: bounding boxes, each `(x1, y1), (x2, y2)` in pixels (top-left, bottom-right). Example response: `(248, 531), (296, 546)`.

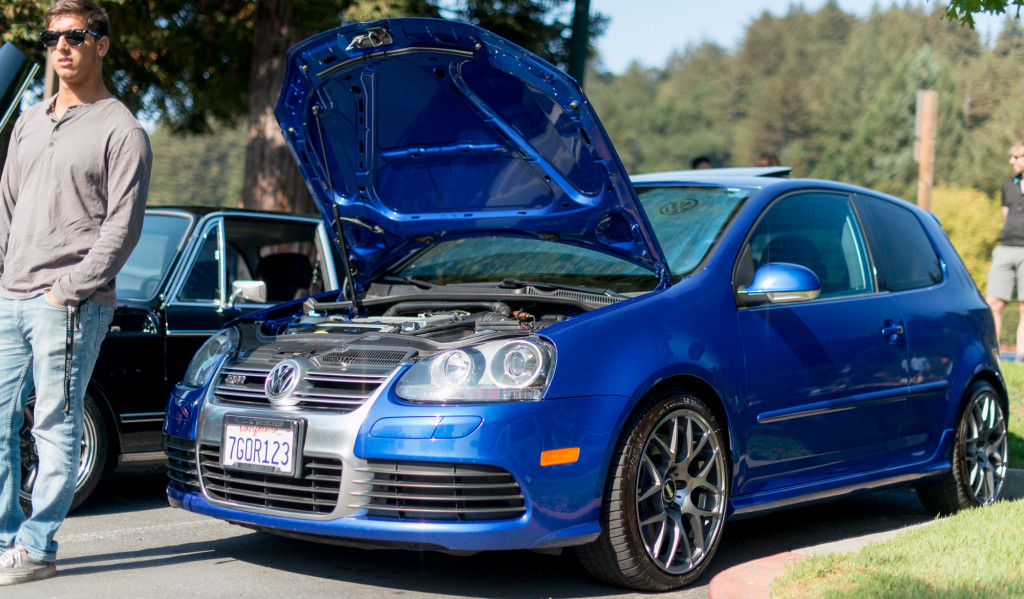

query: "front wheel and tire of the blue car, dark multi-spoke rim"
(575, 389), (730, 591)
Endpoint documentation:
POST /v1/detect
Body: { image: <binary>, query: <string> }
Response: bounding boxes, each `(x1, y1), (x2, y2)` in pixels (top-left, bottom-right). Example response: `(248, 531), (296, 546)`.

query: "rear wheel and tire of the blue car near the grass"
(916, 381), (1007, 515)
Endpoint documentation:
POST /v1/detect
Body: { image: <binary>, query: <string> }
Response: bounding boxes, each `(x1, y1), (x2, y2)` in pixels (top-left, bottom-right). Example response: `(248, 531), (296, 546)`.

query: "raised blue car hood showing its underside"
(275, 18), (671, 287)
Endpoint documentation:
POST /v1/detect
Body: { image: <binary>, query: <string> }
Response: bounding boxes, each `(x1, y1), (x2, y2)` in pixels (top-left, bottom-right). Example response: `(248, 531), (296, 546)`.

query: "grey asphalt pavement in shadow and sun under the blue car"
(0, 471), (1024, 599)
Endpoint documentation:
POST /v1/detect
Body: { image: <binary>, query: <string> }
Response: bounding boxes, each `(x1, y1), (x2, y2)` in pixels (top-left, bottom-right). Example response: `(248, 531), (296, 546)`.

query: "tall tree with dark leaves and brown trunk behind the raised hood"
(0, 0), (602, 212)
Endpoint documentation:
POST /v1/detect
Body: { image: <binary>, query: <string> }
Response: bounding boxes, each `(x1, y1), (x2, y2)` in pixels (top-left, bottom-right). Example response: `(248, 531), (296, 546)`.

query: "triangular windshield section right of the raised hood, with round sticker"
(636, 185), (758, 281)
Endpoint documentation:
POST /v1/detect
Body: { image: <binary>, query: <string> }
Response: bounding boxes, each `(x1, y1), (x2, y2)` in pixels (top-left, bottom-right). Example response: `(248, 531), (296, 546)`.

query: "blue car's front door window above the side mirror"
(737, 192), (873, 298)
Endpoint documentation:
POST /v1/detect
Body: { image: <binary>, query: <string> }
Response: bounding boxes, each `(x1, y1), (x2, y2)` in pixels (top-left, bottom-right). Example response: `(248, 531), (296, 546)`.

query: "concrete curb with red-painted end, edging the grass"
(708, 468), (1024, 599)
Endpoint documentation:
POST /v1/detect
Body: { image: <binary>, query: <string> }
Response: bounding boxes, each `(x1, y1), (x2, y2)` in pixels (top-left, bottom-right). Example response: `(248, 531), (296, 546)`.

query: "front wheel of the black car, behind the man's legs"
(18, 392), (109, 514)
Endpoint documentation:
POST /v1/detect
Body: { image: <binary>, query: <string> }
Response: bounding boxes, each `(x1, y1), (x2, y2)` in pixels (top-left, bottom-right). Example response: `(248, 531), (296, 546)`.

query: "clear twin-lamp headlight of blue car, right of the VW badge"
(395, 337), (555, 403)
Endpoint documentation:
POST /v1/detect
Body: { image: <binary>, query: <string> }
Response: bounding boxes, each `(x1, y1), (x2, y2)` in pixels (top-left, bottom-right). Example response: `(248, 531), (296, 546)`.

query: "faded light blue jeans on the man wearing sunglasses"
(0, 295), (114, 561)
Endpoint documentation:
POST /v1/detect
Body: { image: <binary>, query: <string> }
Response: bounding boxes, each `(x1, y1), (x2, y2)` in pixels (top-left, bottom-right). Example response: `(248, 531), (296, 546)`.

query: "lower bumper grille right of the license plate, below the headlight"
(350, 460), (526, 521)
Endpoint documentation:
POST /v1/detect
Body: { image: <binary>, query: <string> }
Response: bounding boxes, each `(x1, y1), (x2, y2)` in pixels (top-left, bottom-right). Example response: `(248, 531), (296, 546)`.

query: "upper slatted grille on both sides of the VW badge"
(214, 345), (411, 414)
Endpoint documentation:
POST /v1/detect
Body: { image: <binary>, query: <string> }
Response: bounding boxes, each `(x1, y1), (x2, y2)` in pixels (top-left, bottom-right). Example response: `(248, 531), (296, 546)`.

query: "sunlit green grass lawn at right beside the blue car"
(771, 362), (1024, 599)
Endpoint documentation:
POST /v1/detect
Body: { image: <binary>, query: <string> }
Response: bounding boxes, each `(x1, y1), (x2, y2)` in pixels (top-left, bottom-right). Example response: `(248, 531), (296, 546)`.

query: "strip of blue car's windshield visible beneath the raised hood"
(392, 237), (658, 293)
